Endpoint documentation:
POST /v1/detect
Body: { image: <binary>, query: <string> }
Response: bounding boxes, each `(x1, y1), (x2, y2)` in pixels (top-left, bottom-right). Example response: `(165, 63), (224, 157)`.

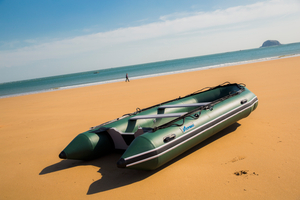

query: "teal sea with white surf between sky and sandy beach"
(0, 43), (300, 98)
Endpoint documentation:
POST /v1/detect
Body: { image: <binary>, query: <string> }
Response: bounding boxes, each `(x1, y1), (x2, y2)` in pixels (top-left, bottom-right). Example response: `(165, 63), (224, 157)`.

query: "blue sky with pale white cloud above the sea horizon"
(0, 0), (300, 83)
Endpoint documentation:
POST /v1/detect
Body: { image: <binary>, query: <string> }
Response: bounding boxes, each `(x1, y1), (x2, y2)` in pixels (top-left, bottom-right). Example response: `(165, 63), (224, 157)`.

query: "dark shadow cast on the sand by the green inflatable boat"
(40, 123), (240, 195)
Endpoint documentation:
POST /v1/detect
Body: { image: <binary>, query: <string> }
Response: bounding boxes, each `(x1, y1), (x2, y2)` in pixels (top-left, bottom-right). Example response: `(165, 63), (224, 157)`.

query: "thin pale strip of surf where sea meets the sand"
(0, 54), (300, 99)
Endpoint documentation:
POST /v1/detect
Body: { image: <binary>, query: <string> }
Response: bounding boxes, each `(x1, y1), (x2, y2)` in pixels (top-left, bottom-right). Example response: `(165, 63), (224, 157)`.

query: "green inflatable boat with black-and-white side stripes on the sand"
(59, 82), (258, 170)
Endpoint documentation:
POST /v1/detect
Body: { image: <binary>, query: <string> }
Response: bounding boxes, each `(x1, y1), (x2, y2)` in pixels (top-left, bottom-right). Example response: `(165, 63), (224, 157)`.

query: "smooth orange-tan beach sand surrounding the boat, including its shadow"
(0, 56), (300, 200)
